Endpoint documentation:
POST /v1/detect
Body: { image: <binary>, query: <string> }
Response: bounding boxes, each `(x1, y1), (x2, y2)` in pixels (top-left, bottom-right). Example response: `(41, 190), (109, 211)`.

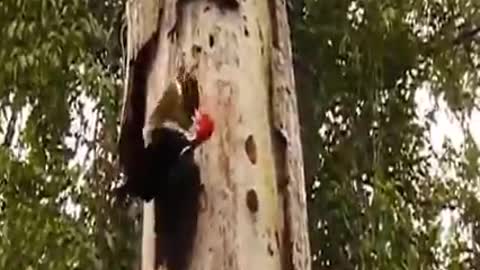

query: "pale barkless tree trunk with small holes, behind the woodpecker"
(121, 0), (310, 270)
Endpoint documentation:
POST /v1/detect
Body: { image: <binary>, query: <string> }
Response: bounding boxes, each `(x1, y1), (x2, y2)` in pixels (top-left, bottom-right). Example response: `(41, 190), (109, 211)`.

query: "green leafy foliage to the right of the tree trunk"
(292, 0), (480, 269)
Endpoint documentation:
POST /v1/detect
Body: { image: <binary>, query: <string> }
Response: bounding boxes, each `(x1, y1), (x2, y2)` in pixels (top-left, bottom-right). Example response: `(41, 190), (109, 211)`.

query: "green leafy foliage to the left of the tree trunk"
(0, 0), (137, 269)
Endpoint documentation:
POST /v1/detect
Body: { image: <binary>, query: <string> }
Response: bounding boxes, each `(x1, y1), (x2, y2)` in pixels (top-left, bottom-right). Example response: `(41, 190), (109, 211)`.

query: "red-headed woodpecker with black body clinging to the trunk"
(117, 77), (214, 202)
